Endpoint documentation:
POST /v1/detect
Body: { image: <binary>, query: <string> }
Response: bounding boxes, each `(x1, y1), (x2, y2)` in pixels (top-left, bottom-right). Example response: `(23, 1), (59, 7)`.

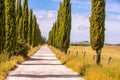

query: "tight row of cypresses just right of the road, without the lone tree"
(48, 0), (71, 52)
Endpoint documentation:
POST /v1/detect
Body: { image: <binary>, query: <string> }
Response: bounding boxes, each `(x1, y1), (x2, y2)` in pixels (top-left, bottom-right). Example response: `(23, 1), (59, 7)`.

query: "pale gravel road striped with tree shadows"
(6, 46), (83, 80)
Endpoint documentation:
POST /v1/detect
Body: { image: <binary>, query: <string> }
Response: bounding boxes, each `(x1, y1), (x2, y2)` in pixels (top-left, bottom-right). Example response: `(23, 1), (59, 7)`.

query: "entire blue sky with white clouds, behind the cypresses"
(28, 0), (120, 43)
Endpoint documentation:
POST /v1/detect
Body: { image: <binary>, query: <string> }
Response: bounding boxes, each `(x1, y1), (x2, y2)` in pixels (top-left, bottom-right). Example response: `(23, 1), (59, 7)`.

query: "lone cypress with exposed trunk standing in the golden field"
(90, 0), (105, 65)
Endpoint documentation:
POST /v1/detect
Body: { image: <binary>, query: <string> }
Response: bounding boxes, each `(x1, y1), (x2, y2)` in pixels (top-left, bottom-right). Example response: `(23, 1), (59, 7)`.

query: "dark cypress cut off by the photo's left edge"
(0, 0), (5, 53)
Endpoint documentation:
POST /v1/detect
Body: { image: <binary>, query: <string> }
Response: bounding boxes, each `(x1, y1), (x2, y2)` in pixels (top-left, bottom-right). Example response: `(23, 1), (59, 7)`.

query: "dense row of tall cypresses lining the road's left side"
(0, 0), (44, 56)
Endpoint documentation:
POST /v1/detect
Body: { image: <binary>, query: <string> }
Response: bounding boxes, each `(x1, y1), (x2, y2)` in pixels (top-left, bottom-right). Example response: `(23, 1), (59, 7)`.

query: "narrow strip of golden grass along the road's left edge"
(0, 46), (40, 80)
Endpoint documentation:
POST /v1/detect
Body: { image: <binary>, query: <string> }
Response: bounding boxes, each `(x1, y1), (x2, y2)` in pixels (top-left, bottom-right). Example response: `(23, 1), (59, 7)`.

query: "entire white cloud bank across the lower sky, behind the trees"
(34, 11), (120, 43)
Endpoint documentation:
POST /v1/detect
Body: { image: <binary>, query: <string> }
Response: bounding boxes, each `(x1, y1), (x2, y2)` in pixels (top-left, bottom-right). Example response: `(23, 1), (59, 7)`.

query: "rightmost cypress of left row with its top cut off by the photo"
(22, 0), (28, 42)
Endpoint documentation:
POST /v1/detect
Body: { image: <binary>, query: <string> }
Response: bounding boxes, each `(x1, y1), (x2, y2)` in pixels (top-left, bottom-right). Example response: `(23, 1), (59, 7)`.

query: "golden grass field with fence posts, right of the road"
(50, 46), (120, 80)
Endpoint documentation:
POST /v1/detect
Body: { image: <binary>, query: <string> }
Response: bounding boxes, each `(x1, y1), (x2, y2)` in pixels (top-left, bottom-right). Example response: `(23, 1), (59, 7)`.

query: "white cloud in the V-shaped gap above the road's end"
(34, 10), (57, 37)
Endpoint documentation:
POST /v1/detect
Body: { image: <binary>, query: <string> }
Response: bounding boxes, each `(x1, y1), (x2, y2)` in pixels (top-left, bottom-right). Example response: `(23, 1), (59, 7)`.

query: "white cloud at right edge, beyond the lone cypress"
(105, 20), (120, 43)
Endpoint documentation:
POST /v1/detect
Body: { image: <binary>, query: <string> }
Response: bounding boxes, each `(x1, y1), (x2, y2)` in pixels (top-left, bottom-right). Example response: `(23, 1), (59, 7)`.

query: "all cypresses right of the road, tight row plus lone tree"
(48, 0), (105, 65)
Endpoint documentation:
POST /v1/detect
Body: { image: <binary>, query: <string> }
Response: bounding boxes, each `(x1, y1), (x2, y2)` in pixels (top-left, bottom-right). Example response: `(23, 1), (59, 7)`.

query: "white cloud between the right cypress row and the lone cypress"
(71, 14), (89, 42)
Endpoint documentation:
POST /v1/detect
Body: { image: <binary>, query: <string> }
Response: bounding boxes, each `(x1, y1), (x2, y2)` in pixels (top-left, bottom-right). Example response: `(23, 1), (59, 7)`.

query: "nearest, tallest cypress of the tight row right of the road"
(58, 0), (71, 52)
